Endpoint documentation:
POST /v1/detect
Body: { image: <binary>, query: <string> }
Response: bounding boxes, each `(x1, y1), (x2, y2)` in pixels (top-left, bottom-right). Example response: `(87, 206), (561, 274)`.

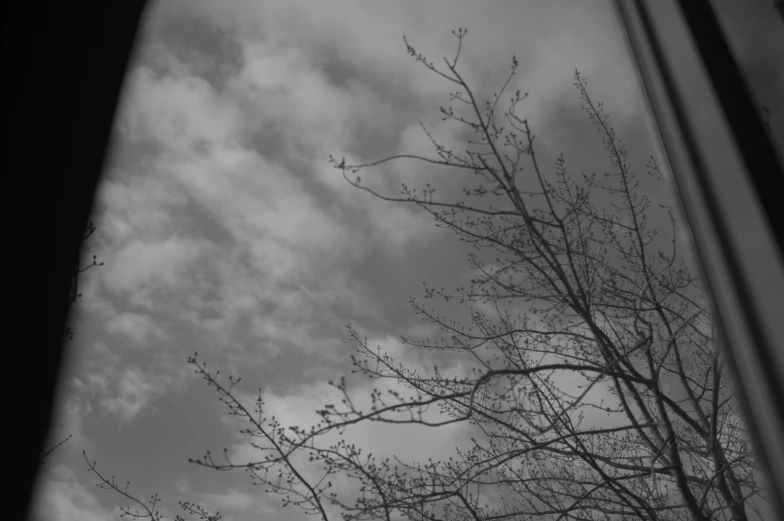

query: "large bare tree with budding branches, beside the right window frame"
(189, 29), (772, 521)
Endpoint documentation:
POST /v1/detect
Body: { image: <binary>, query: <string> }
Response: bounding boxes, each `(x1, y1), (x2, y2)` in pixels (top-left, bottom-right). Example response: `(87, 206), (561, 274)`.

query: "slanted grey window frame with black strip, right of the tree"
(615, 0), (784, 519)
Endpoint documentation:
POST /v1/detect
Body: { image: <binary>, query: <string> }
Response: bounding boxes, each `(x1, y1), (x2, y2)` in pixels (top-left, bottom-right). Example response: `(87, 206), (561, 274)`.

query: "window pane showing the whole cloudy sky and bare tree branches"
(33, 0), (772, 520)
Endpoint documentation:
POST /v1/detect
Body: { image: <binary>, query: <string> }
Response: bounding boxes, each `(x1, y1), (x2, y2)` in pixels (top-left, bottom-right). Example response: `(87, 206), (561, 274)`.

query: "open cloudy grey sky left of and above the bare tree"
(29, 0), (784, 521)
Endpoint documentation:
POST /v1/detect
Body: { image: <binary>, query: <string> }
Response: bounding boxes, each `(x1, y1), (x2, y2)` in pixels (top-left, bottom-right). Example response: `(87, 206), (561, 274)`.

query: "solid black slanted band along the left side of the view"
(0, 0), (146, 521)
